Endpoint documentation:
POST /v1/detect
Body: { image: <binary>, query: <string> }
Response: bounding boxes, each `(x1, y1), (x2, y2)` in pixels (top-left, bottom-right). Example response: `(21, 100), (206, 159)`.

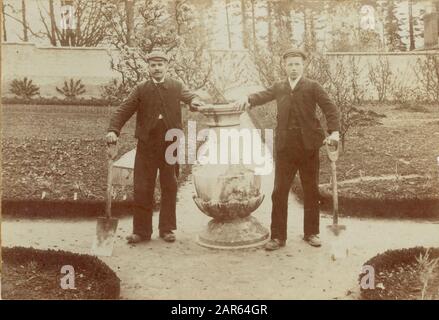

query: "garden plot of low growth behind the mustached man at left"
(2, 105), (208, 201)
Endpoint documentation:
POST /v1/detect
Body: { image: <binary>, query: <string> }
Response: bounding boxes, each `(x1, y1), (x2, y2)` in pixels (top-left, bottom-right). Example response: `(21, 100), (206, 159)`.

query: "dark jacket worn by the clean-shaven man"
(249, 76), (340, 150)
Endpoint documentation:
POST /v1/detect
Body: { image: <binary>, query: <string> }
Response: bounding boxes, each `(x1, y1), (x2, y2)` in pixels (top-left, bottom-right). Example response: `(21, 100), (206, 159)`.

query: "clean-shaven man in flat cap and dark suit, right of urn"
(236, 49), (340, 251)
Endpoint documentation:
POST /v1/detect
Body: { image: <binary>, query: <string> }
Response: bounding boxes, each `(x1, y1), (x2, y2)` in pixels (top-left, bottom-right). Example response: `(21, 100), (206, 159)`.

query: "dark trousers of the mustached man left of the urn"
(133, 120), (177, 236)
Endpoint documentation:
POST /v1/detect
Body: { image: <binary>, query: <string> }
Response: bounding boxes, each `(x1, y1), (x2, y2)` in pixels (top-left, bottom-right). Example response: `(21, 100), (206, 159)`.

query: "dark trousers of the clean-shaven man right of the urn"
(271, 130), (319, 240)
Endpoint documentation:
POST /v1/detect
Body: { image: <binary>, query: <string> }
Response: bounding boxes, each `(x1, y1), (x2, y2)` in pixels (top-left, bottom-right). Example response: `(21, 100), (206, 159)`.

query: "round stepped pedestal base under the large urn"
(197, 216), (269, 249)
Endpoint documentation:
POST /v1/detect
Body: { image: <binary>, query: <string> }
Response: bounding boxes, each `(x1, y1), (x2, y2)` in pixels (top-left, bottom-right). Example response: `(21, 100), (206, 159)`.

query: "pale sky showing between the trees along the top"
(2, 0), (432, 51)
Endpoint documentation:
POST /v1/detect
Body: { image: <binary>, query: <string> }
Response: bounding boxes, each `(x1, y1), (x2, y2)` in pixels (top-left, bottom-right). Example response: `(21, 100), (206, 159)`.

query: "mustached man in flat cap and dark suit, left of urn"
(106, 50), (204, 243)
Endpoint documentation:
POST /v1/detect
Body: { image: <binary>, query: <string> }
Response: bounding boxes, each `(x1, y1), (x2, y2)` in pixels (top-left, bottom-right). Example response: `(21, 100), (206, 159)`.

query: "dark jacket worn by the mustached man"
(108, 77), (196, 142)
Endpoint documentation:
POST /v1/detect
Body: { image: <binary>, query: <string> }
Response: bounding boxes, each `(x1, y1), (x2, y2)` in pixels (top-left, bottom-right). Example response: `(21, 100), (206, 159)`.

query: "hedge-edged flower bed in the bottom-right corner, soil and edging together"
(359, 247), (439, 300)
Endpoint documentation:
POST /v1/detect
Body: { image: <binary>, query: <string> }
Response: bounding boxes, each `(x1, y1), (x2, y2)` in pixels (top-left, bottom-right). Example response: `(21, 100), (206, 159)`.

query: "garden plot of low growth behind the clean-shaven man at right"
(250, 103), (439, 199)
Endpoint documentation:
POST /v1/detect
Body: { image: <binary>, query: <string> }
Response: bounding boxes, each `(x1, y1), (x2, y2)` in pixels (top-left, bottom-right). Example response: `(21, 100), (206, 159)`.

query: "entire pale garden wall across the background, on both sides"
(2, 43), (439, 100)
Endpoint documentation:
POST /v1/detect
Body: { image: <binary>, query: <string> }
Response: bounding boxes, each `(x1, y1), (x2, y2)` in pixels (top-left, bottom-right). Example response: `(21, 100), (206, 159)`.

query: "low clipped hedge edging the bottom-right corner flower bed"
(358, 247), (439, 300)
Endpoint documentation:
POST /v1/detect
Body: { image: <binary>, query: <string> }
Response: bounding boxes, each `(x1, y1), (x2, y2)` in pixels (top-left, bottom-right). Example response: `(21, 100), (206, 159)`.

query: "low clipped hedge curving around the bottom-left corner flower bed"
(1, 247), (120, 300)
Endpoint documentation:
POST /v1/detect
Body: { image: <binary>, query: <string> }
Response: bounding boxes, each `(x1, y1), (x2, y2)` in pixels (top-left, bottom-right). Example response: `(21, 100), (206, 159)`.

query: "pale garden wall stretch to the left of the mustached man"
(1, 43), (119, 98)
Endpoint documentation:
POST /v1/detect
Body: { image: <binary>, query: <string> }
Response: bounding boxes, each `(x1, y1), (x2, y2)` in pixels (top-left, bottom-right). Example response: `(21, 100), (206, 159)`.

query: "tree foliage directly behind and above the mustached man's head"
(105, 0), (211, 89)
